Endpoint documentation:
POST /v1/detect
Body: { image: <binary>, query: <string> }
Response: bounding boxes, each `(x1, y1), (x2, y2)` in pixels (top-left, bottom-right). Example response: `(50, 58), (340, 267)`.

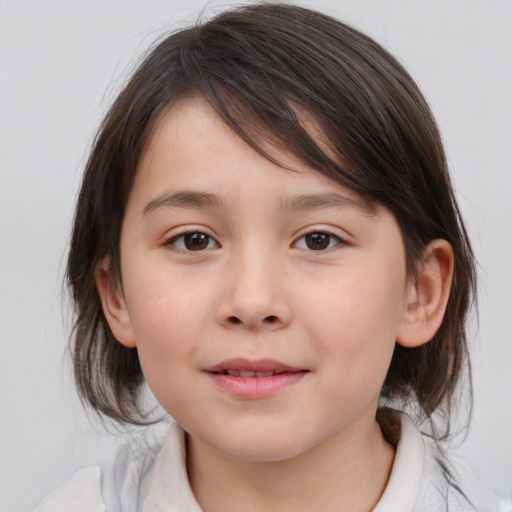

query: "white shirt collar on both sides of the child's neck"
(143, 414), (425, 512)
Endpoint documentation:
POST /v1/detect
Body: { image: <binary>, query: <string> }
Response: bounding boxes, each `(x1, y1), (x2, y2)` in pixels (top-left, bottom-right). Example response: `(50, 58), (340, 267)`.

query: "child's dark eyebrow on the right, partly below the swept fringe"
(281, 192), (375, 217)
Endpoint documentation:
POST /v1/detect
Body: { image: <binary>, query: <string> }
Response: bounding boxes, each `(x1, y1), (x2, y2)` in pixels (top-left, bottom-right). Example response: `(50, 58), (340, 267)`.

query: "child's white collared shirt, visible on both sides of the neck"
(33, 415), (512, 512)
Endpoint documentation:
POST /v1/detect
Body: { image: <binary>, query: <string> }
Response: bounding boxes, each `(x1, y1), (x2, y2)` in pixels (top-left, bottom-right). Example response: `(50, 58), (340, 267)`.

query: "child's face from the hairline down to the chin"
(110, 99), (407, 460)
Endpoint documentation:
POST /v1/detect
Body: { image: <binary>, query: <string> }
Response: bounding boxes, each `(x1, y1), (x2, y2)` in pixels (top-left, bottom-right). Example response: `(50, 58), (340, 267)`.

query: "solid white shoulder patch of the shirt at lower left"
(32, 466), (106, 512)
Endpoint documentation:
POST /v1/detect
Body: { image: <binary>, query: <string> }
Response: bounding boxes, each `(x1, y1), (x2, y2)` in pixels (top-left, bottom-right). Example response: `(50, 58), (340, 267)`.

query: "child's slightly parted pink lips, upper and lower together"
(204, 359), (308, 399)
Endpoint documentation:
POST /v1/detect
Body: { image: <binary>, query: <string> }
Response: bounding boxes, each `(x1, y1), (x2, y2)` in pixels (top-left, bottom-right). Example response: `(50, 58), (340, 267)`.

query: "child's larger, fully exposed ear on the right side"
(396, 239), (453, 347)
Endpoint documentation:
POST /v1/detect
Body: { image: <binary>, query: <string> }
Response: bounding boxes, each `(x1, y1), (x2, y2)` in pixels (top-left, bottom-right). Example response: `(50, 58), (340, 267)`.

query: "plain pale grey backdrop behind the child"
(0, 0), (512, 512)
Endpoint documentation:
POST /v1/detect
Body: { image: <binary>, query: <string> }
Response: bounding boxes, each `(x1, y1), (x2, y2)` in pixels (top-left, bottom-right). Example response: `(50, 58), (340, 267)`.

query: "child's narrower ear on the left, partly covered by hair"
(94, 258), (136, 348)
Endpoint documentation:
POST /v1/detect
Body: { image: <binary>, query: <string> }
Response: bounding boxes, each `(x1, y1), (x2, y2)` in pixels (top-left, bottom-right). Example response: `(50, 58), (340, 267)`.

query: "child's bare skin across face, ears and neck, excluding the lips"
(97, 99), (453, 512)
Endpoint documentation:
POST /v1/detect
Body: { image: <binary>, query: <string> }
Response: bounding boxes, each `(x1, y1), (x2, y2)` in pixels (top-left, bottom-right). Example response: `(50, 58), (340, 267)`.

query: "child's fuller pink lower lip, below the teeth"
(207, 372), (307, 399)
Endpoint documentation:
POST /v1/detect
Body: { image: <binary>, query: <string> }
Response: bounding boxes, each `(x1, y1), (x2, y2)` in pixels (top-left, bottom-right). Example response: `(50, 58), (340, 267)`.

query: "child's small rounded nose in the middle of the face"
(218, 249), (292, 331)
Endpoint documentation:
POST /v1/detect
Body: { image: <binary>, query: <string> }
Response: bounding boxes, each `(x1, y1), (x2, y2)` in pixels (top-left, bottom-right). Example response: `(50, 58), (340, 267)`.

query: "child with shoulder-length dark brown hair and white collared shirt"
(33, 4), (508, 512)
